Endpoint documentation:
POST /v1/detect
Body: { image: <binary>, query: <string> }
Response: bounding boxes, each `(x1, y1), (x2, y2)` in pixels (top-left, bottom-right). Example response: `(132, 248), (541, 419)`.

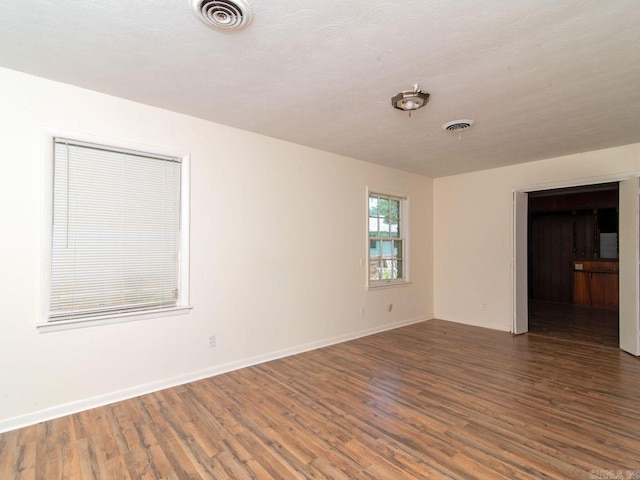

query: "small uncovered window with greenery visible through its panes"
(368, 193), (408, 287)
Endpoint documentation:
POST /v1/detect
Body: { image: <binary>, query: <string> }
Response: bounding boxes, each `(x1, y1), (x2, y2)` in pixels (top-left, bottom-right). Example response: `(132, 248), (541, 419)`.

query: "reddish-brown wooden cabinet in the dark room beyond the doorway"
(573, 259), (618, 308)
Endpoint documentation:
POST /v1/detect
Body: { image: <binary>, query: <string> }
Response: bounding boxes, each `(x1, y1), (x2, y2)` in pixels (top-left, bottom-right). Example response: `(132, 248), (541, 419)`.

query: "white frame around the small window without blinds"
(365, 187), (411, 290)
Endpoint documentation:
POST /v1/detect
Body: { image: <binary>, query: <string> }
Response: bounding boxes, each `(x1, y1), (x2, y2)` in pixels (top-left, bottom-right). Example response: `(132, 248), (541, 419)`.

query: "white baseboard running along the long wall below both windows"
(0, 317), (433, 433)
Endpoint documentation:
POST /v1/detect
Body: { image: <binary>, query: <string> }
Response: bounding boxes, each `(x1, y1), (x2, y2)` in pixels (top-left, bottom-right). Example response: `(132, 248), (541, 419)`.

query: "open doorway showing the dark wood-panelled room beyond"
(527, 182), (619, 347)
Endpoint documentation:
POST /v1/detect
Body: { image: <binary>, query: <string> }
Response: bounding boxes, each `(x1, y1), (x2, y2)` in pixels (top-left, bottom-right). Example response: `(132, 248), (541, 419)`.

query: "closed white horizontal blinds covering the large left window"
(49, 138), (181, 321)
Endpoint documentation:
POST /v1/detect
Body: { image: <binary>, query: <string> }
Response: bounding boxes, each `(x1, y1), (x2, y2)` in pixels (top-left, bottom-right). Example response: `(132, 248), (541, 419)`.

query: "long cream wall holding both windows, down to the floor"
(0, 69), (433, 431)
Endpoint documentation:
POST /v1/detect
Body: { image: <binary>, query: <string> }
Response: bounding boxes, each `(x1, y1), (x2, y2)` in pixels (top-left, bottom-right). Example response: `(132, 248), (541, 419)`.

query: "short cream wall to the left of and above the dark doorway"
(433, 144), (640, 331)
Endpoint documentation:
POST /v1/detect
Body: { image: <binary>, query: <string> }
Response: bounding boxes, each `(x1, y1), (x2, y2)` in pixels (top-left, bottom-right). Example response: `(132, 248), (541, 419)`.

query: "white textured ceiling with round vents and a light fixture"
(0, 0), (640, 177)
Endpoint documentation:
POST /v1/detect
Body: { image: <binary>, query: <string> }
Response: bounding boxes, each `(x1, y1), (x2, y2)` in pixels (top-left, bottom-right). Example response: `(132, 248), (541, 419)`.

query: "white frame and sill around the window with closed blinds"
(36, 127), (192, 333)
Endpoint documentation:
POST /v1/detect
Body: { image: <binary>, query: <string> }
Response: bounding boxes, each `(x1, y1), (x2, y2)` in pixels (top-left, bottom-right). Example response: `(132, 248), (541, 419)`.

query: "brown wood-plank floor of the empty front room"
(0, 320), (640, 480)
